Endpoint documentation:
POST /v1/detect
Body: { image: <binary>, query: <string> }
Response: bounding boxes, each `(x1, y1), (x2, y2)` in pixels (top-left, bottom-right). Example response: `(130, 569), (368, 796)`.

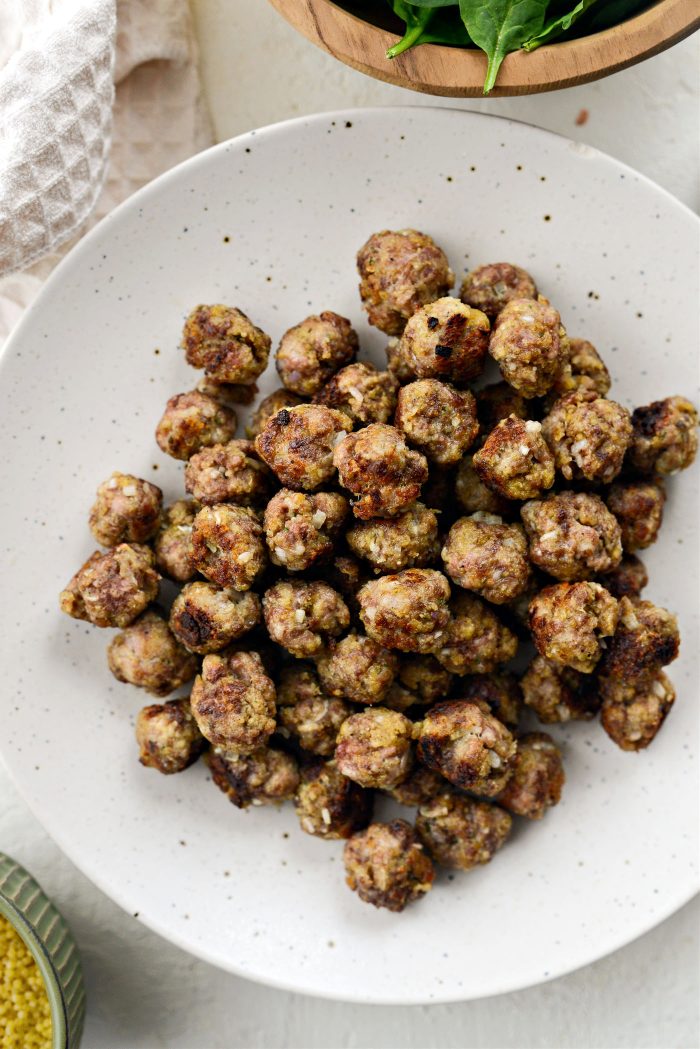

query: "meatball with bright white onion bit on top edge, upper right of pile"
(473, 415), (554, 499)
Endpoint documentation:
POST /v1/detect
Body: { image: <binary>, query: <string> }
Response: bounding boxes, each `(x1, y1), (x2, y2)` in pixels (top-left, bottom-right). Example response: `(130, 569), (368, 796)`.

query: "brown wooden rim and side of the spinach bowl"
(265, 0), (700, 98)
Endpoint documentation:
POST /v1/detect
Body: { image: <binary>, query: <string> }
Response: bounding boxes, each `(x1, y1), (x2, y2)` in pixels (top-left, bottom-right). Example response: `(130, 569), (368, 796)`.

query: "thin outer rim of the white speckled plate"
(0, 104), (700, 1006)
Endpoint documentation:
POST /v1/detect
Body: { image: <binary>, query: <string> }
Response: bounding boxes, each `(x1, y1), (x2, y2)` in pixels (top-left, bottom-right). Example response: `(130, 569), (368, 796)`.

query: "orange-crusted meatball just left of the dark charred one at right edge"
(530, 582), (619, 673)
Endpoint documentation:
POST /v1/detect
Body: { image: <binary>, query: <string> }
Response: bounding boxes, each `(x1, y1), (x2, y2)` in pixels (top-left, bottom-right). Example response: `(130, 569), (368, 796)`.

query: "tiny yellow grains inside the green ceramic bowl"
(0, 916), (51, 1049)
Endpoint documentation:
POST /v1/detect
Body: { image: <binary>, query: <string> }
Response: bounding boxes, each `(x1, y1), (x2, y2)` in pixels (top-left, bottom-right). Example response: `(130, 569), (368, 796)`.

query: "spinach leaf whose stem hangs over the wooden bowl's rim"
(460, 0), (548, 94)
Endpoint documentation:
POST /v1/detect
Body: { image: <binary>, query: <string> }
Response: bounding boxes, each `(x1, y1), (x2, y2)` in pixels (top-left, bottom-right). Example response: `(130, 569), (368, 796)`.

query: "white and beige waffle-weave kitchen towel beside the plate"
(0, 0), (212, 343)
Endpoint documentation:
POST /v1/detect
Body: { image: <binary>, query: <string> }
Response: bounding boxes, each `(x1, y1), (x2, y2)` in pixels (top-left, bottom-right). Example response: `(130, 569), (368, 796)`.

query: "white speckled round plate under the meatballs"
(0, 109), (698, 1003)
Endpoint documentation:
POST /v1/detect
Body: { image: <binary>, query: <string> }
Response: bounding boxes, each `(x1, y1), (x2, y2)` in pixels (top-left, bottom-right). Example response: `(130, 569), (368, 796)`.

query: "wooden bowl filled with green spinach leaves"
(265, 0), (700, 98)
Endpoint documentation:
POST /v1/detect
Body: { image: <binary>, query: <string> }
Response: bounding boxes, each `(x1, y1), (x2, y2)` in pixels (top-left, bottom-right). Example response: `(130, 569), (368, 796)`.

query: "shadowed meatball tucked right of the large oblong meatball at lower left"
(277, 663), (353, 757)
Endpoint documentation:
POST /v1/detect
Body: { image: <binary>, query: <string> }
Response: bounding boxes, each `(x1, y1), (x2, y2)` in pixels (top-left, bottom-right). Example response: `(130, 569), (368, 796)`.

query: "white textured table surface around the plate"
(0, 0), (700, 1049)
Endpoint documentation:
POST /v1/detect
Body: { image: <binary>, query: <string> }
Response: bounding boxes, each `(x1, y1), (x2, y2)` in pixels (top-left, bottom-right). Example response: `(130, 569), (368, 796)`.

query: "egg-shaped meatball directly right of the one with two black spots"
(489, 299), (569, 398)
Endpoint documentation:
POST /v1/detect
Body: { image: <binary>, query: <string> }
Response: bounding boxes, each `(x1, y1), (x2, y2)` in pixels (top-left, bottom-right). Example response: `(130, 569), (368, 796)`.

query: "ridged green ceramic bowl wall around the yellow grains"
(0, 853), (85, 1049)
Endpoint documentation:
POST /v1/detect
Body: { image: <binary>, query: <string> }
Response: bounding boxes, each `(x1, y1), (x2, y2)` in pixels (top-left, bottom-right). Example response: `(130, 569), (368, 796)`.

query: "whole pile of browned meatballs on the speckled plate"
(60, 230), (698, 911)
